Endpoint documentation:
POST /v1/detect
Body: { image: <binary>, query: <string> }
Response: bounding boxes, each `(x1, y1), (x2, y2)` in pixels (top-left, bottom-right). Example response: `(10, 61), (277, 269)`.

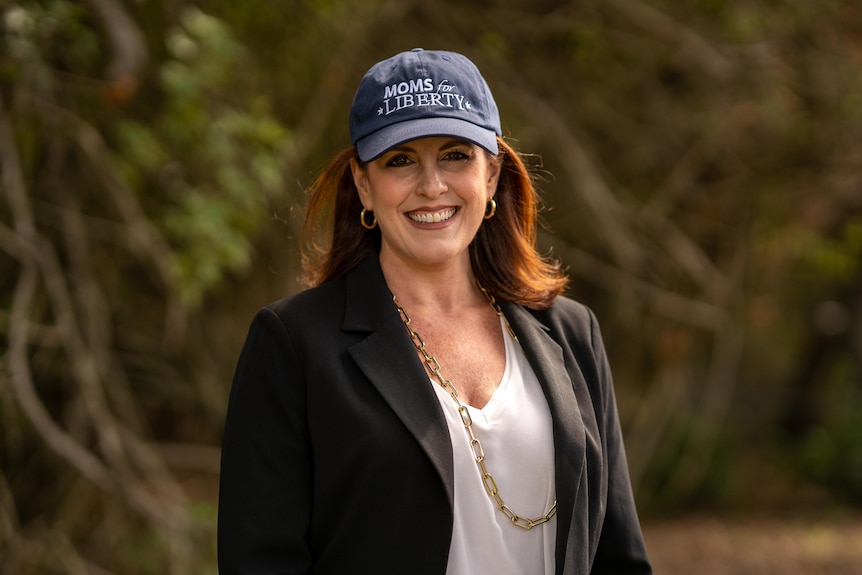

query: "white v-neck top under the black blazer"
(432, 318), (557, 575)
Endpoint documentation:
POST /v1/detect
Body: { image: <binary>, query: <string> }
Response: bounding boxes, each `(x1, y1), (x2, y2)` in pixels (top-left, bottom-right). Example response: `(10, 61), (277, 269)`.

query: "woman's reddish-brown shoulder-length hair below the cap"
(301, 138), (568, 309)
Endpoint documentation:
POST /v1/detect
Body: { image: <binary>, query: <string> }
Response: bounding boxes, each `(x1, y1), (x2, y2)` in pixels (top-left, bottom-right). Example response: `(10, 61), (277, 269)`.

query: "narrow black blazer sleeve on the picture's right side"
(587, 311), (652, 575)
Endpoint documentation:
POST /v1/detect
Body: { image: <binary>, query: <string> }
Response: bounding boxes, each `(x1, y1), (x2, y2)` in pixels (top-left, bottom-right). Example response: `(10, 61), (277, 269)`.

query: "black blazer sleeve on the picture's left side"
(218, 308), (312, 575)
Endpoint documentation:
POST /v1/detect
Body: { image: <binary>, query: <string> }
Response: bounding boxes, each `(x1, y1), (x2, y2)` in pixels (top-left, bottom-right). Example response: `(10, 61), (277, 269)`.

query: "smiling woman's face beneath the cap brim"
(351, 137), (500, 274)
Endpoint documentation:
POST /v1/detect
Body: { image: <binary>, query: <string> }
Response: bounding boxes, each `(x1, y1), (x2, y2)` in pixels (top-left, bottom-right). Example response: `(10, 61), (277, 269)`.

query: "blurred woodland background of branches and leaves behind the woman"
(0, 0), (862, 575)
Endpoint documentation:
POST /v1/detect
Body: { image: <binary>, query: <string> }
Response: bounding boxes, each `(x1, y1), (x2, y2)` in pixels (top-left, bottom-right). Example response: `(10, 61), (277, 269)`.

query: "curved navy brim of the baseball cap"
(356, 118), (498, 162)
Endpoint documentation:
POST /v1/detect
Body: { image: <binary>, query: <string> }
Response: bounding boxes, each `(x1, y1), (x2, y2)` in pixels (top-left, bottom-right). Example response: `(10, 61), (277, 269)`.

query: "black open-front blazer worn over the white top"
(218, 256), (651, 575)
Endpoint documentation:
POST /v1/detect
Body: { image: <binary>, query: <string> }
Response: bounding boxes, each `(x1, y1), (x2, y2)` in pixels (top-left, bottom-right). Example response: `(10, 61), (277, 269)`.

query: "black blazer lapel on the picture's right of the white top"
(500, 302), (587, 572)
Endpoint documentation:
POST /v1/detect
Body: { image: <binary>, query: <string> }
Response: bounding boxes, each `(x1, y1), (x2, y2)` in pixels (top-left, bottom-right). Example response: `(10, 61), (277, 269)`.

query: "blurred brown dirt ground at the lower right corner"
(643, 517), (862, 575)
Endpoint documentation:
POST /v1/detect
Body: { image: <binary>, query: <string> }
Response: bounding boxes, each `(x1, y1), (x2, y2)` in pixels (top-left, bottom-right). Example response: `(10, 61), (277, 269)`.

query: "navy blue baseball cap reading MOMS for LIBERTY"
(350, 48), (502, 162)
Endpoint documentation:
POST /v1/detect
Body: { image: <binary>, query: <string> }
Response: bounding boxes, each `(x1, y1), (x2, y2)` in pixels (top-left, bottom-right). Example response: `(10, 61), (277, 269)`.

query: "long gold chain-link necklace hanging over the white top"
(392, 286), (557, 531)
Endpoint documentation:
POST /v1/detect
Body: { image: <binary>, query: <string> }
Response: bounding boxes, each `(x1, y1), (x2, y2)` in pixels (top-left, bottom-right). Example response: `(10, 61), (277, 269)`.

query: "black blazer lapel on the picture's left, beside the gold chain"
(342, 254), (455, 503)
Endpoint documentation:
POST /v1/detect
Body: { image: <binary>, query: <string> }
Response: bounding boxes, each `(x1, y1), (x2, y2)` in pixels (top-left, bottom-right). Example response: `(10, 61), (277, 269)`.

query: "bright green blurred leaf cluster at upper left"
(115, 9), (290, 305)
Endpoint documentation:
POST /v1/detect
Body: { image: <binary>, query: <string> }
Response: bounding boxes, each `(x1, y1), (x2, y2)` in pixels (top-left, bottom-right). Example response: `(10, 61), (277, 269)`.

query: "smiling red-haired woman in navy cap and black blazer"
(219, 49), (651, 575)
